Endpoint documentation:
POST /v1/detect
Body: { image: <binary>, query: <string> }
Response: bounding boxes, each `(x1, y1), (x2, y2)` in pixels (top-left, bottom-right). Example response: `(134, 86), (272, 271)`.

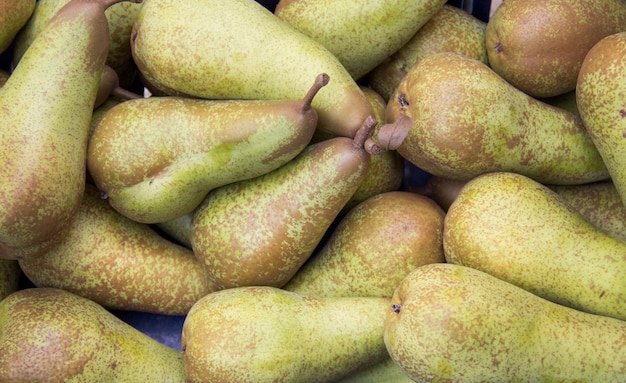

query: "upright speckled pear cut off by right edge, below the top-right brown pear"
(576, 32), (626, 207)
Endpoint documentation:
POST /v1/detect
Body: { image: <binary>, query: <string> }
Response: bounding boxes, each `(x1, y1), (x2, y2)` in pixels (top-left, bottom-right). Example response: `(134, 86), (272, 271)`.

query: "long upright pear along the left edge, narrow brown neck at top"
(0, 0), (138, 259)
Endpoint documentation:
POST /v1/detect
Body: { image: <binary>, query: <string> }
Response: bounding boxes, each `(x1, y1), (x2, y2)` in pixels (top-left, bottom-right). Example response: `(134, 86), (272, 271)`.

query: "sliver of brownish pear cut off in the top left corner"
(0, 0), (37, 53)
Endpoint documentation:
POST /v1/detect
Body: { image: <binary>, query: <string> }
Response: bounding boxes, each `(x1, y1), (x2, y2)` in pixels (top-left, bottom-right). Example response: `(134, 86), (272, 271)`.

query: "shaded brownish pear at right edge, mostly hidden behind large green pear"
(547, 180), (626, 241)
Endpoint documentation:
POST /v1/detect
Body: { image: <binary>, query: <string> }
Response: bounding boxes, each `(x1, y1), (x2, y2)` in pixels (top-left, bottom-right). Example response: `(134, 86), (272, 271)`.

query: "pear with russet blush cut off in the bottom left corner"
(0, 288), (185, 383)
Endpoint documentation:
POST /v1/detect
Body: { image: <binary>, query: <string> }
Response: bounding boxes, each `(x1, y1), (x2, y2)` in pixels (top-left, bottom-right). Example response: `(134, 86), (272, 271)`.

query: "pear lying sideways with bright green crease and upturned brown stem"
(87, 74), (329, 223)
